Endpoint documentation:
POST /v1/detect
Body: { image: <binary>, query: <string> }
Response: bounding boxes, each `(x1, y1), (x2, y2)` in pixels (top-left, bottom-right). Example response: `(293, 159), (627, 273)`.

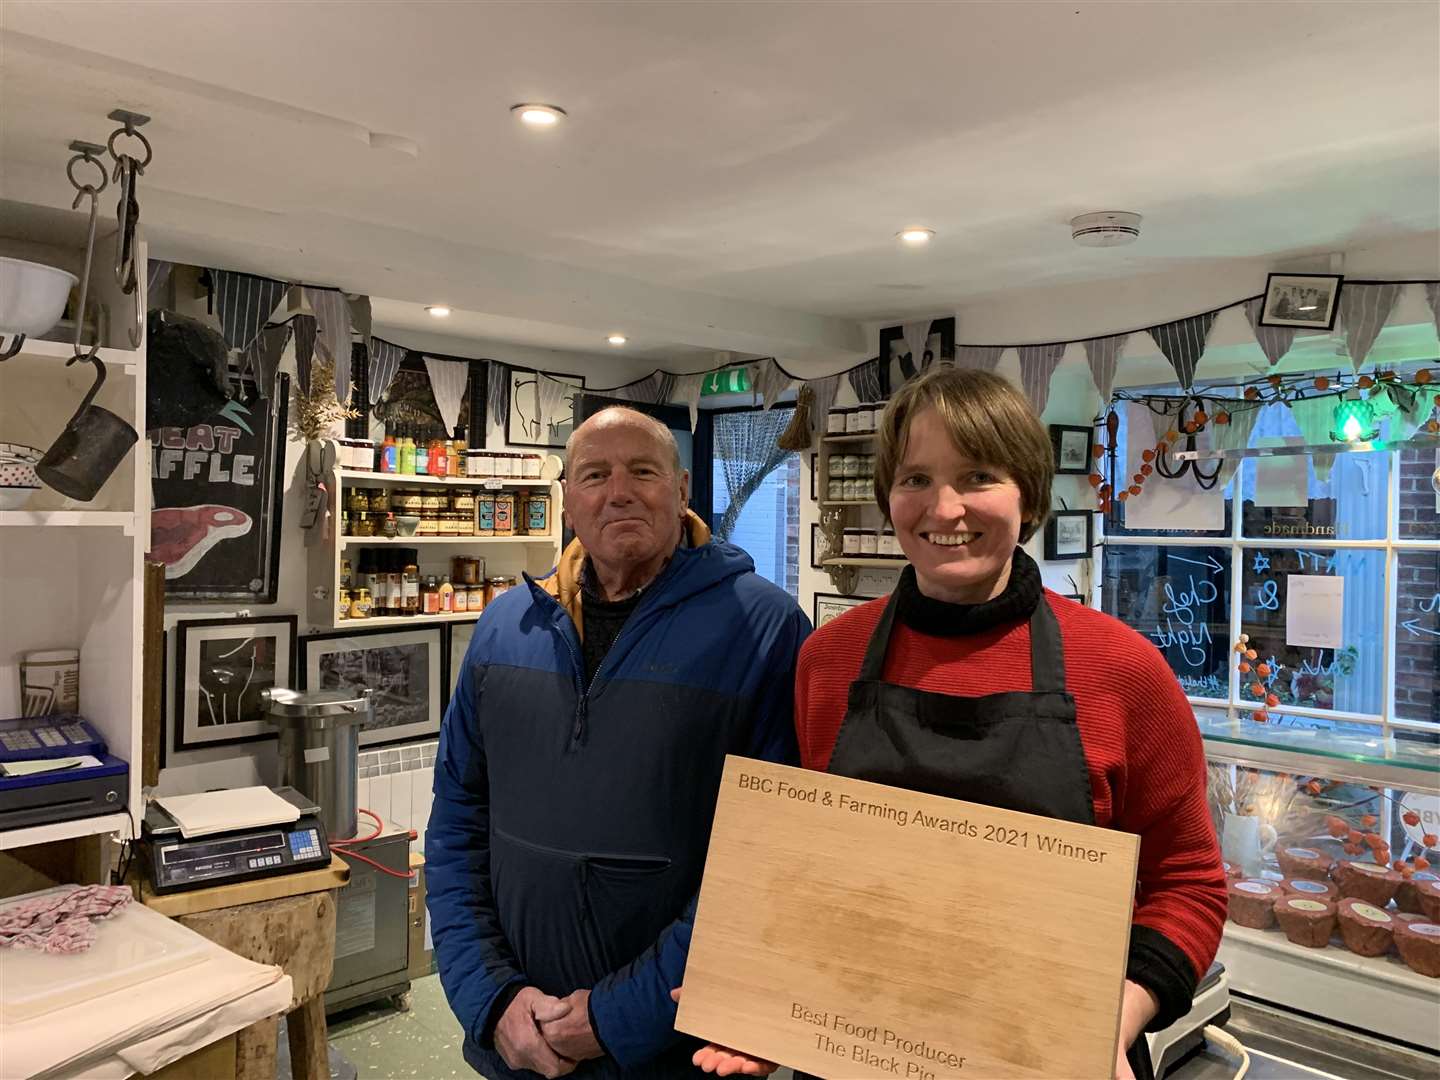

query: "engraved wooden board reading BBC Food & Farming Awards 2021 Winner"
(675, 756), (1139, 1080)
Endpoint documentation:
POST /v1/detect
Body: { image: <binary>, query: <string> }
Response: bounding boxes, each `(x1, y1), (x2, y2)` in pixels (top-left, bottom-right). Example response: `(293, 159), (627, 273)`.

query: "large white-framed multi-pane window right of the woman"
(1102, 361), (1440, 743)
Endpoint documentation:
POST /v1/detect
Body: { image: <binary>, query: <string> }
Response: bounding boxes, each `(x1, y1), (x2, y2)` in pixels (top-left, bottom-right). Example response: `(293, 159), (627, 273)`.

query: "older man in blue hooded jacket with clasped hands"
(425, 406), (809, 1080)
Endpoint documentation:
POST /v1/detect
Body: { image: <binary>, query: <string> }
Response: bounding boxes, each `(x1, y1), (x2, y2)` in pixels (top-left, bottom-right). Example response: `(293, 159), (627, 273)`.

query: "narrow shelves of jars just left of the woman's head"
(814, 431), (906, 595)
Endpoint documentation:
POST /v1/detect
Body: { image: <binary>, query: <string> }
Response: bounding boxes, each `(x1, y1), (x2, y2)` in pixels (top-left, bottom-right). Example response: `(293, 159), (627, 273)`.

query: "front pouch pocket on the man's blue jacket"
(580, 854), (673, 972)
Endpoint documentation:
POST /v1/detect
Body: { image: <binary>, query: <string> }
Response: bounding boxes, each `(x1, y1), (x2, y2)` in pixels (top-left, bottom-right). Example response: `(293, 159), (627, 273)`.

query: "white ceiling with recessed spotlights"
(0, 0), (1440, 369)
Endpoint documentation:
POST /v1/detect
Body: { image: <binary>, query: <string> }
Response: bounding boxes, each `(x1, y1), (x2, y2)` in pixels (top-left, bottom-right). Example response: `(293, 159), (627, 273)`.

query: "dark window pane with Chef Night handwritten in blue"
(1102, 544), (1231, 700)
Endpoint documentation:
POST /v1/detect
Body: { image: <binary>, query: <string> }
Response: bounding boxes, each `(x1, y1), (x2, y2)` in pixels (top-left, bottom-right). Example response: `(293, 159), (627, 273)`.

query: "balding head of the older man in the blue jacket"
(564, 413), (690, 567)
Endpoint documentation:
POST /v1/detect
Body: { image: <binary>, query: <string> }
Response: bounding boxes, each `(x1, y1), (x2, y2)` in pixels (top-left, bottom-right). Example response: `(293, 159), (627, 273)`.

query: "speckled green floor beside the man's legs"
(330, 975), (478, 1080)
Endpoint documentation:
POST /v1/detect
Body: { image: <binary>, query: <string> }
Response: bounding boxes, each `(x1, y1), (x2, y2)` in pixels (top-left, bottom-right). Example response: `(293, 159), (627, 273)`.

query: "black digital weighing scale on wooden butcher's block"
(141, 788), (330, 894)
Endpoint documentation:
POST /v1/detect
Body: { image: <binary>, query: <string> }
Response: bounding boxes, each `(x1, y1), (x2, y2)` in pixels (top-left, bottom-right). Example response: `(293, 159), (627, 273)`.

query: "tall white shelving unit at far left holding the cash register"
(0, 197), (150, 850)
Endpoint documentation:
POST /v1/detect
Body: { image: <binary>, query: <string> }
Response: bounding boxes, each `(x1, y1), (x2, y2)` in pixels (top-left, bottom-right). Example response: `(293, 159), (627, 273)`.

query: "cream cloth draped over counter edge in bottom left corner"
(0, 904), (291, 1080)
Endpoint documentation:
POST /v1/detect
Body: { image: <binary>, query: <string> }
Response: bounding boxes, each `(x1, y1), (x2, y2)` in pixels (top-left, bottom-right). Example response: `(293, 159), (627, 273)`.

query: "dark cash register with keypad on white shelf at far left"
(0, 713), (130, 829)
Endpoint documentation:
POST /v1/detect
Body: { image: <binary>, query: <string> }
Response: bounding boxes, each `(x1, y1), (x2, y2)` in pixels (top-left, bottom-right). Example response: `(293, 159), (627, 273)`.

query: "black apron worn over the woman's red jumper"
(827, 595), (1155, 1080)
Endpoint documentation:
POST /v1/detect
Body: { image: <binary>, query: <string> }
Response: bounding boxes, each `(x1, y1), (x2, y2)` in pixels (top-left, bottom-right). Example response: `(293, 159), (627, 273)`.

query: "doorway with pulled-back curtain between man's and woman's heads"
(710, 409), (801, 598)
